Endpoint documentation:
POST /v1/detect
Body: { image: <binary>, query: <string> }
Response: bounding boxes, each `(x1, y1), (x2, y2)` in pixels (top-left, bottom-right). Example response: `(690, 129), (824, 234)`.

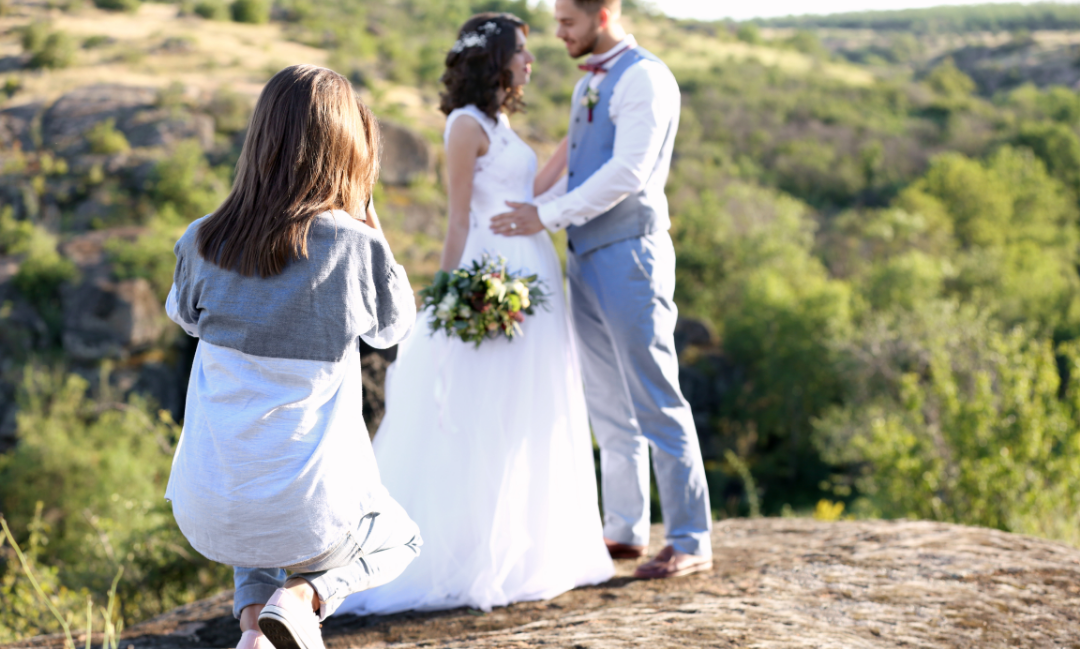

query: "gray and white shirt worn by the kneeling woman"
(165, 212), (416, 568)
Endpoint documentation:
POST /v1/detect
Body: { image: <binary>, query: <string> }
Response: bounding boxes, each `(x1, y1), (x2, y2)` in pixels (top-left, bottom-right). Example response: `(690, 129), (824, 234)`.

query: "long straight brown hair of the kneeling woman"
(198, 65), (379, 278)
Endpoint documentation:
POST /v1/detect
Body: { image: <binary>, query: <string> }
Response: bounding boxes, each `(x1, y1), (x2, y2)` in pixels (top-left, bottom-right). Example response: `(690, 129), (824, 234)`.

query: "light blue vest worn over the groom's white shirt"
(566, 48), (678, 255)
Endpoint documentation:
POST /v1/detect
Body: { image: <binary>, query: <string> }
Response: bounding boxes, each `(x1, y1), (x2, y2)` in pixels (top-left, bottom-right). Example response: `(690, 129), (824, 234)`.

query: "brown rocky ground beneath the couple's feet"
(10, 518), (1080, 649)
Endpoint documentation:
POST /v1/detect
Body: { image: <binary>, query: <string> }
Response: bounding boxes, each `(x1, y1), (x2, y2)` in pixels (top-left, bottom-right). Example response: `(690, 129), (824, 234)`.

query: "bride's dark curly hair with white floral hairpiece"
(438, 12), (529, 119)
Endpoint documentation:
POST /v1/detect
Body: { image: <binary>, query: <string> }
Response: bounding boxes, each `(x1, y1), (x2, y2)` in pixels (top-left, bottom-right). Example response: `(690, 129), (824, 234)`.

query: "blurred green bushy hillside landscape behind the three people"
(8, 0), (1080, 641)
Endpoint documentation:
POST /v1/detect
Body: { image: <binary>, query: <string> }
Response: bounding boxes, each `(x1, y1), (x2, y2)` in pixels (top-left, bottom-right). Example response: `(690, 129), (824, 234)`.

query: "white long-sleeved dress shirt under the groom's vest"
(537, 35), (681, 231)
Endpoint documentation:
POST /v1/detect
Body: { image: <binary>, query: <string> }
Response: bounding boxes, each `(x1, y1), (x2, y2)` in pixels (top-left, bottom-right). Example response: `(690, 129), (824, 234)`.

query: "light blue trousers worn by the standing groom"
(566, 232), (712, 556)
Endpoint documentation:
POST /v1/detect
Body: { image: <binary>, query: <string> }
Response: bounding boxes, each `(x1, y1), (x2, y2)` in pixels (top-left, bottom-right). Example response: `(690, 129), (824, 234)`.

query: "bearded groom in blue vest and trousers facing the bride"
(491, 0), (712, 579)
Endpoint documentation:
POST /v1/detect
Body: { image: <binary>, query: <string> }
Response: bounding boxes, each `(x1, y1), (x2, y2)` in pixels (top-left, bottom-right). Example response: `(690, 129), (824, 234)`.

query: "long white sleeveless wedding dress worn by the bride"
(339, 106), (613, 614)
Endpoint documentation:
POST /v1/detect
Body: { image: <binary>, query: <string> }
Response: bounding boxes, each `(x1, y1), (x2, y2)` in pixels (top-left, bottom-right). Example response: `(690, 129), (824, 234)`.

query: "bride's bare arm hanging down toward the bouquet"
(440, 114), (488, 272)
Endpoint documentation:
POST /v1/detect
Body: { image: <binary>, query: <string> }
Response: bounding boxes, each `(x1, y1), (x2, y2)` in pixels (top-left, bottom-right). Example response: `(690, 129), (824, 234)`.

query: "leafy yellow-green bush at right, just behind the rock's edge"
(814, 302), (1080, 544)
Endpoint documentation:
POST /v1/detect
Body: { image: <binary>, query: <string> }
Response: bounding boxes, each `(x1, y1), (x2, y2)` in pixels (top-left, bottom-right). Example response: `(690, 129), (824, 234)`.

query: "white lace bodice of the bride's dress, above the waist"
(443, 104), (537, 230)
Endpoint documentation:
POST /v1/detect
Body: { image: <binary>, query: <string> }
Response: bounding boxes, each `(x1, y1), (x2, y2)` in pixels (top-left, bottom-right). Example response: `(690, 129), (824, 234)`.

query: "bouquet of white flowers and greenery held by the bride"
(420, 255), (548, 347)
